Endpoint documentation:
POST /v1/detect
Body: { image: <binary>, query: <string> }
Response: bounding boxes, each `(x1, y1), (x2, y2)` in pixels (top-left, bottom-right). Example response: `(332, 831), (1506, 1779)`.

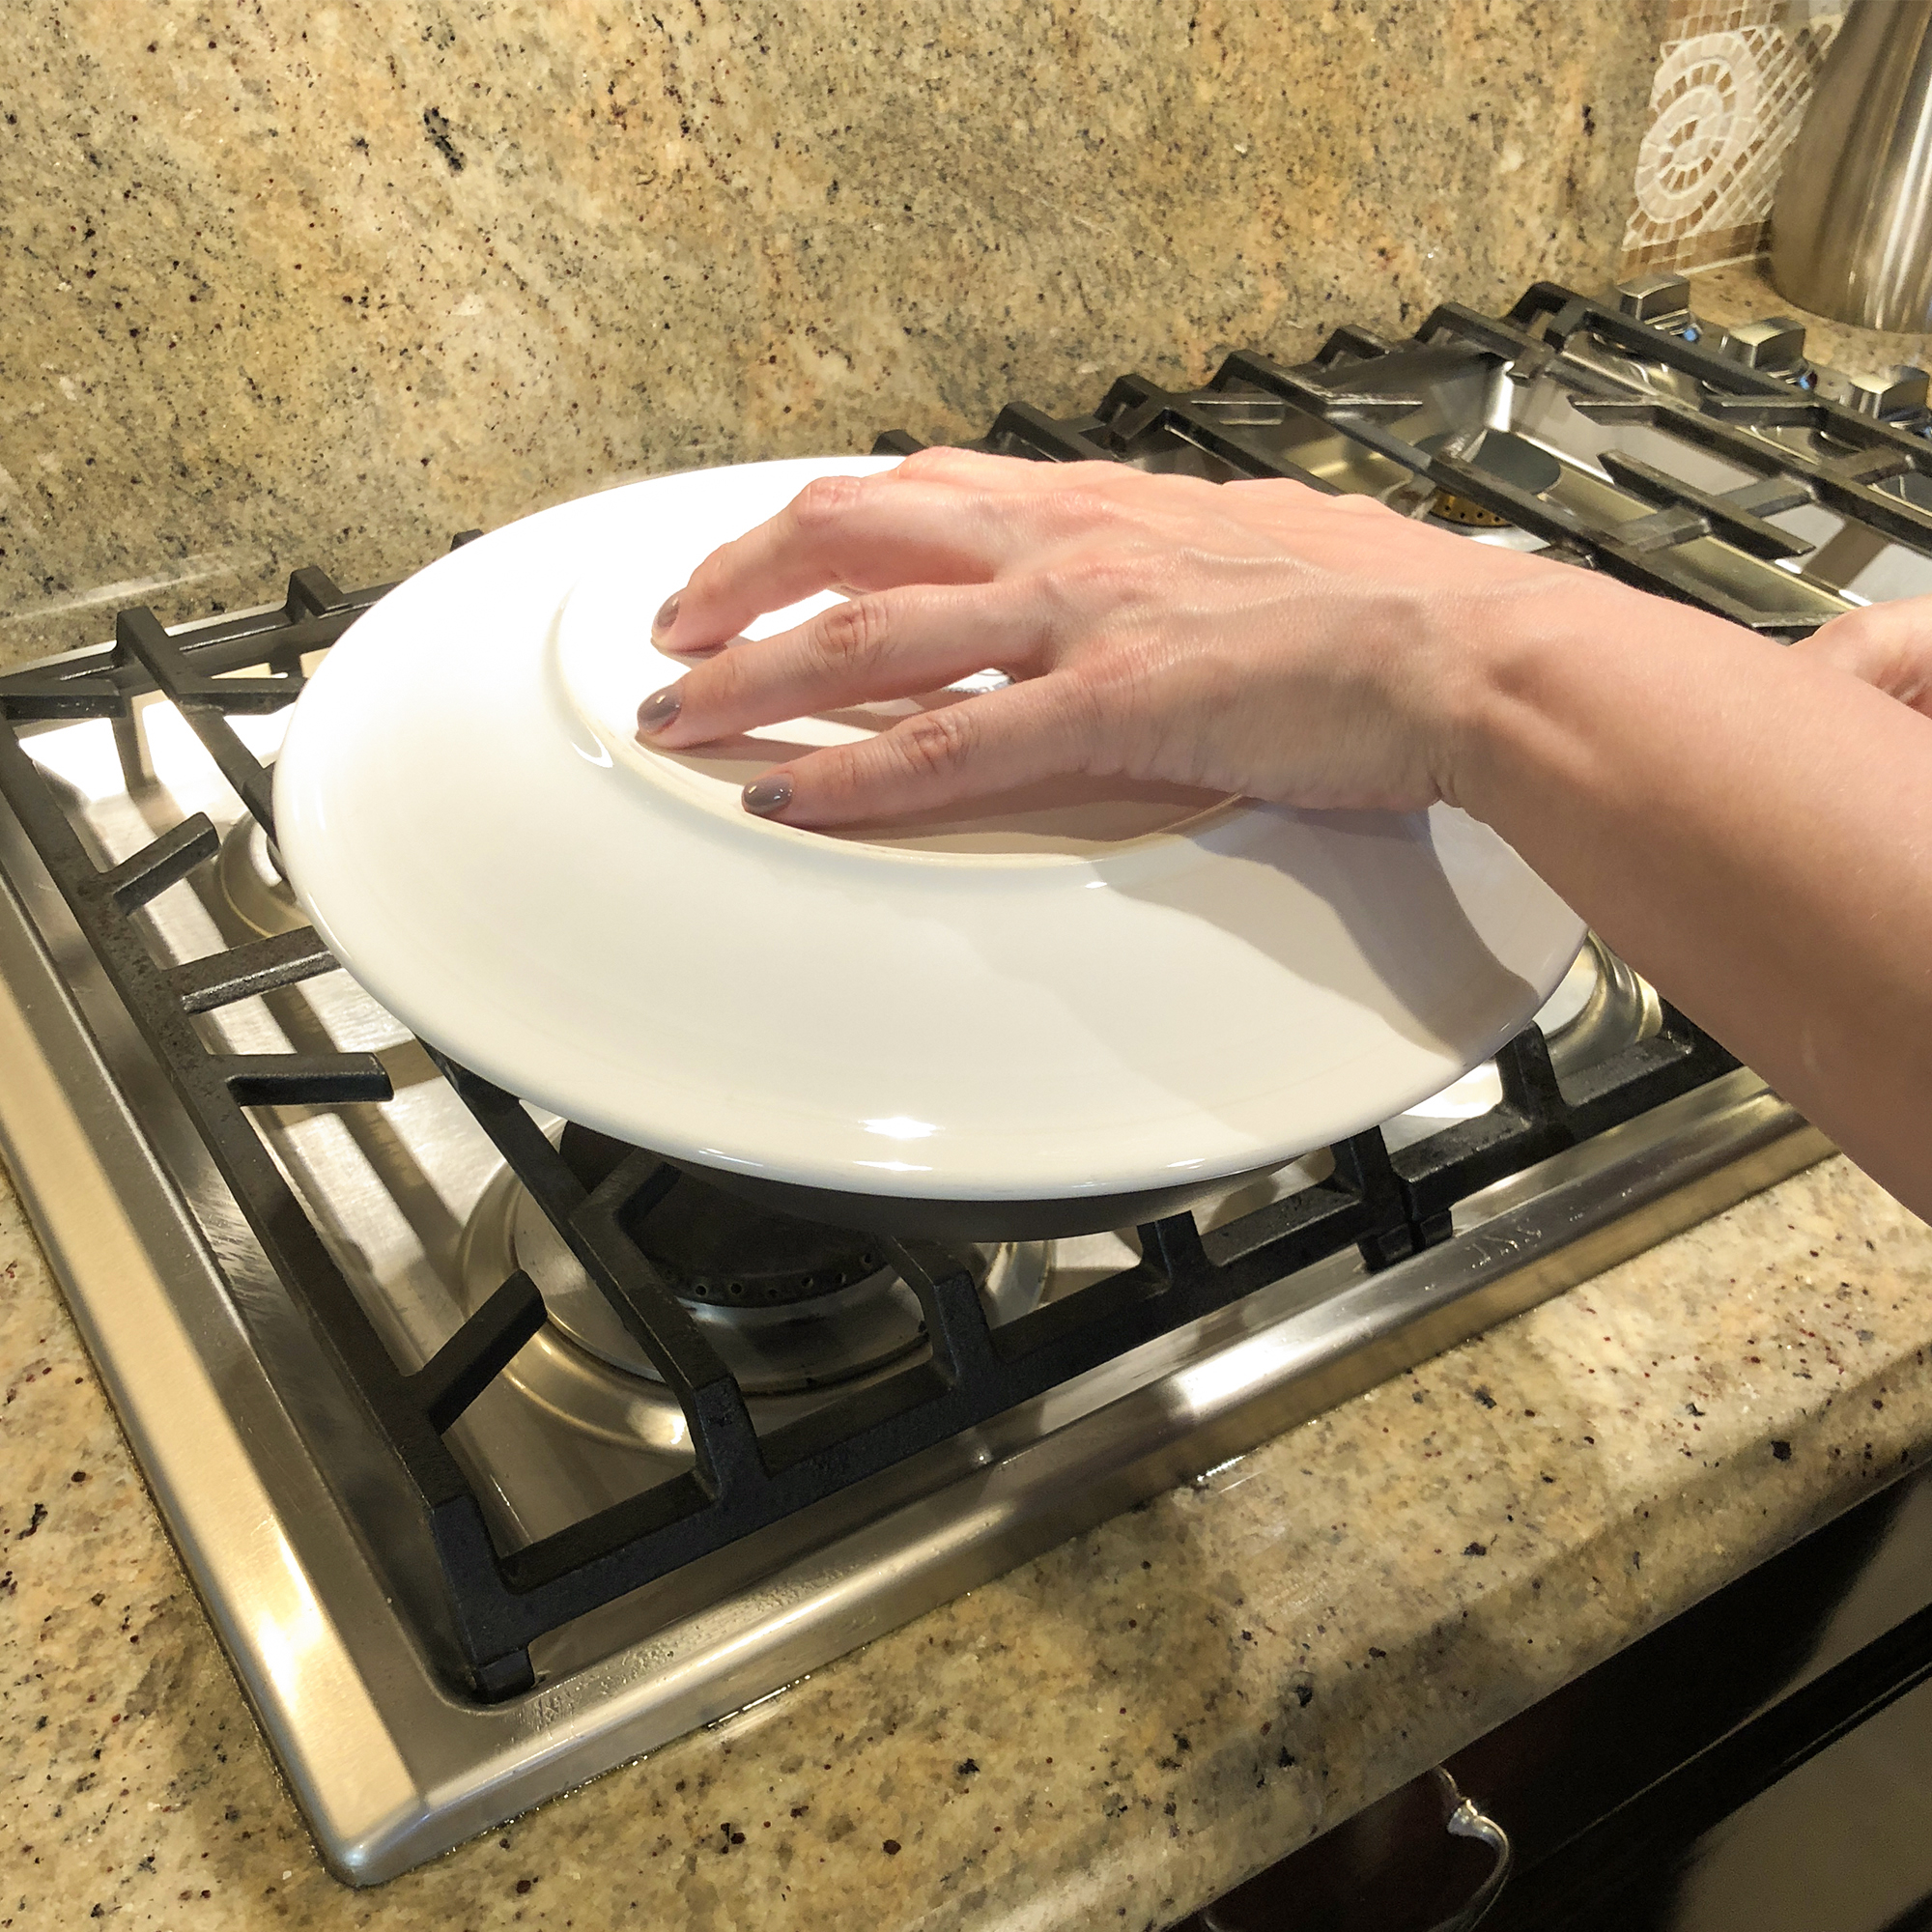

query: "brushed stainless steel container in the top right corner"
(1772, 0), (1932, 328)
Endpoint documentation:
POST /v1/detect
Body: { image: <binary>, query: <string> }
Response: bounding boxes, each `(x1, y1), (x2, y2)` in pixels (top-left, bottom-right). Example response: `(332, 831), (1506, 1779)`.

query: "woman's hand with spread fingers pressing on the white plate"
(639, 450), (1634, 825)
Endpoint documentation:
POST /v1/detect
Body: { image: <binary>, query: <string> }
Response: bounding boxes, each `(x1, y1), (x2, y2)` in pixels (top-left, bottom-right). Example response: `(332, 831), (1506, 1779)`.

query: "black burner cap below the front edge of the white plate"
(562, 1124), (885, 1308)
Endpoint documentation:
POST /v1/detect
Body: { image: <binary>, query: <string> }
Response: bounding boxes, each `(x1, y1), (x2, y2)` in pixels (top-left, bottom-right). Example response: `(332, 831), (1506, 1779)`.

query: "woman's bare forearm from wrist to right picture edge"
(1445, 580), (1932, 1213)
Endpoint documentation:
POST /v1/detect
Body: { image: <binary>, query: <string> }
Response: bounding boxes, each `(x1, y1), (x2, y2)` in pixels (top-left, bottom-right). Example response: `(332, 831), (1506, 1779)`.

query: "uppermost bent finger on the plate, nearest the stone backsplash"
(653, 450), (1037, 653)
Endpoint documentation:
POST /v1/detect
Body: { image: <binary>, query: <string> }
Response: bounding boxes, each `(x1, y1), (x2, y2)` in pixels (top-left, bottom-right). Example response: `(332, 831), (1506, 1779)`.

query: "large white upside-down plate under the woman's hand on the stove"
(274, 458), (1582, 1200)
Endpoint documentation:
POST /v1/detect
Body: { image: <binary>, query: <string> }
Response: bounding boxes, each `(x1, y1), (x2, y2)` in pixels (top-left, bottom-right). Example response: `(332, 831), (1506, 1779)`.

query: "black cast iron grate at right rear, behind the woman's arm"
(875, 282), (1932, 638)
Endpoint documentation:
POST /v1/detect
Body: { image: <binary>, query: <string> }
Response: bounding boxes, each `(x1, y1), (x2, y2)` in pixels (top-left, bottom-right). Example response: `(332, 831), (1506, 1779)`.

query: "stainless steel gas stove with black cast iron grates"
(0, 282), (1901, 1884)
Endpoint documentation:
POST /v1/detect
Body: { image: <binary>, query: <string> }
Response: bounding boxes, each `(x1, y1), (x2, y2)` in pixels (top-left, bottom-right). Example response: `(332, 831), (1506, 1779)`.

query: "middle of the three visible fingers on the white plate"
(638, 585), (1039, 750)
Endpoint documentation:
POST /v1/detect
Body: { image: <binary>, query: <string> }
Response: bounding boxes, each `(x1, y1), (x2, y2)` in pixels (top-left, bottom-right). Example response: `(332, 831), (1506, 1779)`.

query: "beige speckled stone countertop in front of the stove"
(0, 1159), (1932, 1932)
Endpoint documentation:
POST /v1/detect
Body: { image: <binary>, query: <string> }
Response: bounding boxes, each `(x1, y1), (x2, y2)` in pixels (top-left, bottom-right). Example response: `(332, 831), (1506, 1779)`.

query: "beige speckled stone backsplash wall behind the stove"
(0, 0), (1663, 665)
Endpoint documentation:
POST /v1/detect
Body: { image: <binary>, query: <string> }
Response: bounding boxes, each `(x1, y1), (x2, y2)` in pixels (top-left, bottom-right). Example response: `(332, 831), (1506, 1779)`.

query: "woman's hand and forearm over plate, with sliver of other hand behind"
(639, 450), (1932, 1213)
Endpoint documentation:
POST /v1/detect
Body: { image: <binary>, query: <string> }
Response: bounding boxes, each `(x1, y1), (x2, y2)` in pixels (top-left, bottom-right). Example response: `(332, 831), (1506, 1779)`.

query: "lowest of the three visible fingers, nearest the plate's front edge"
(746, 672), (1095, 827)
